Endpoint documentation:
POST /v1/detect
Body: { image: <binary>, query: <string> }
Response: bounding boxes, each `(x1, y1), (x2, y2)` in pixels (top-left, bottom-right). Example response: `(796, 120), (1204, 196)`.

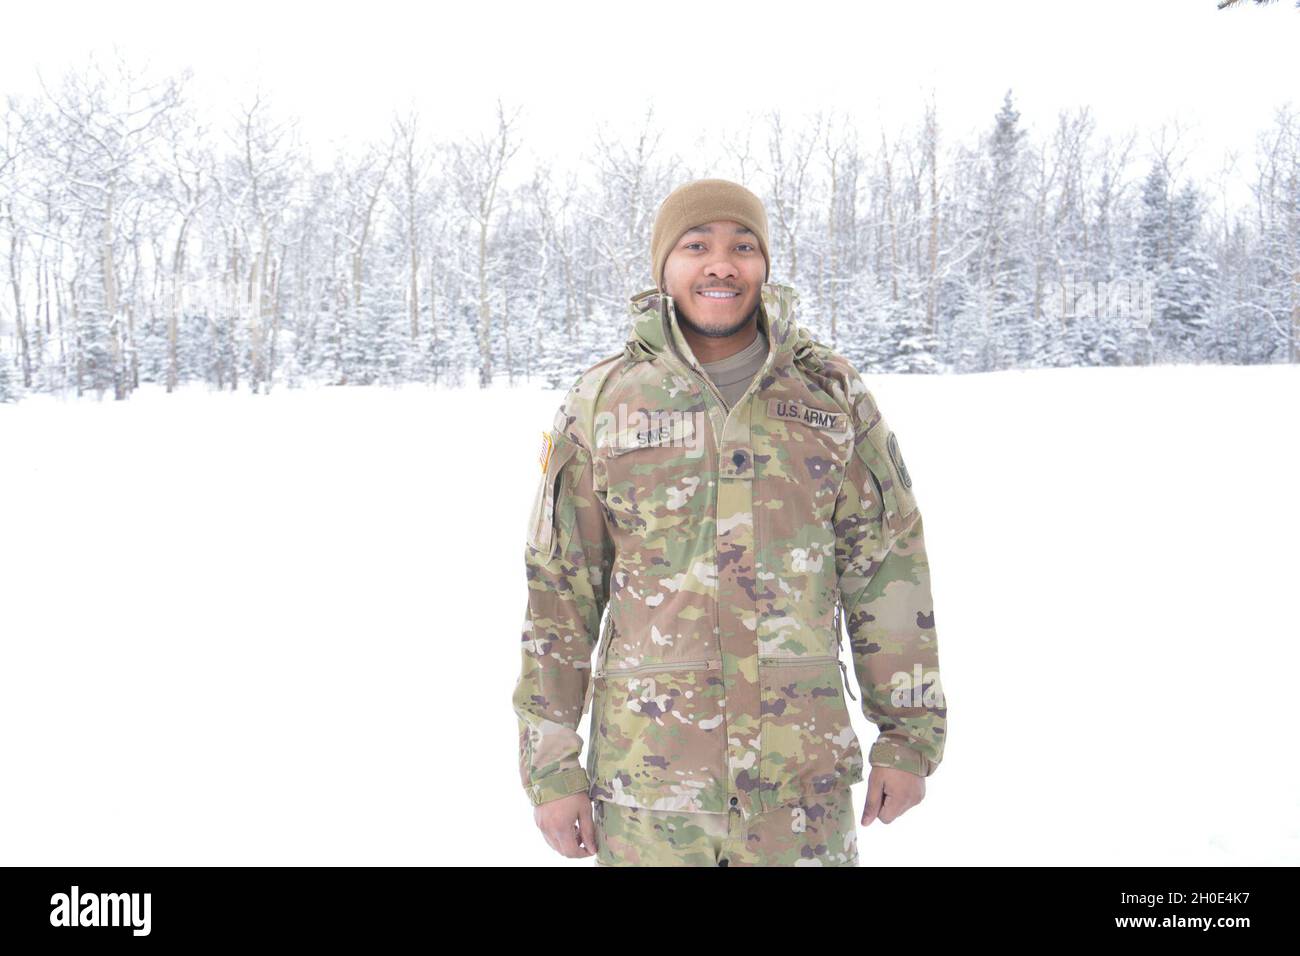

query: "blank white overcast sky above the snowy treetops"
(0, 0), (1300, 201)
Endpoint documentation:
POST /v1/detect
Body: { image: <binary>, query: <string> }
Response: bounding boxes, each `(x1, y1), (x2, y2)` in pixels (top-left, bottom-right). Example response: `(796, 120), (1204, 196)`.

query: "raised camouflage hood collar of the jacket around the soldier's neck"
(623, 282), (813, 369)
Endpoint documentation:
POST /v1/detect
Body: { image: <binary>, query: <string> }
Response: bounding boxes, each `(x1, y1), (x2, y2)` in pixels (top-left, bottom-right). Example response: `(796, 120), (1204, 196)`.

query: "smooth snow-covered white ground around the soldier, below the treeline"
(0, 367), (1300, 866)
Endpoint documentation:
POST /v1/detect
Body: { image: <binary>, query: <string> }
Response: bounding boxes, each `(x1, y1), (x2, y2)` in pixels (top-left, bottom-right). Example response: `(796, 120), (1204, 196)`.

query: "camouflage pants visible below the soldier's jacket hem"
(593, 787), (858, 866)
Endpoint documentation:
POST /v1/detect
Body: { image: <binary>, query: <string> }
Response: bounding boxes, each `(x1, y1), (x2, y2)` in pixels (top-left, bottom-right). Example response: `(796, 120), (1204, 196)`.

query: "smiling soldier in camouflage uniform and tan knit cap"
(514, 179), (946, 866)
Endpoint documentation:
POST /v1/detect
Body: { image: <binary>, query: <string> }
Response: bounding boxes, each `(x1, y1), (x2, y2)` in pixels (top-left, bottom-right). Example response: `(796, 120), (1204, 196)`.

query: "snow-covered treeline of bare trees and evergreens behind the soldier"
(0, 55), (1300, 399)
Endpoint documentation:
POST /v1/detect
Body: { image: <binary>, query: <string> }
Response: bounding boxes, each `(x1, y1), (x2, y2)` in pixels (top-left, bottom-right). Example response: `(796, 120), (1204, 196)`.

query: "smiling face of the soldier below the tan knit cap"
(663, 219), (767, 337)
